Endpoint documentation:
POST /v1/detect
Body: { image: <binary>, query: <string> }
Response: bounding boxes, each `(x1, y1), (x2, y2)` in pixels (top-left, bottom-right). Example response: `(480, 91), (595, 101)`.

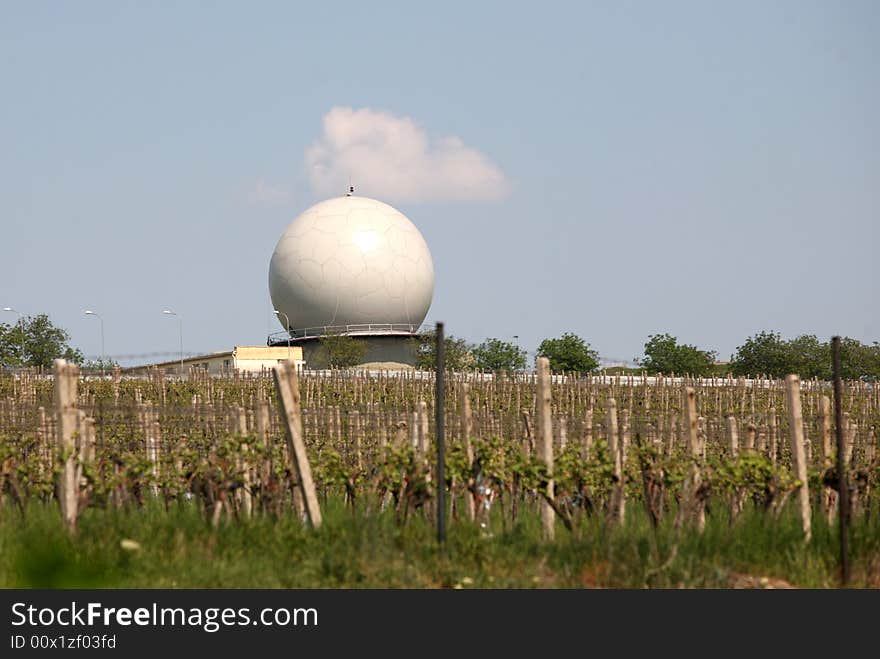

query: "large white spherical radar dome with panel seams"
(269, 195), (434, 330)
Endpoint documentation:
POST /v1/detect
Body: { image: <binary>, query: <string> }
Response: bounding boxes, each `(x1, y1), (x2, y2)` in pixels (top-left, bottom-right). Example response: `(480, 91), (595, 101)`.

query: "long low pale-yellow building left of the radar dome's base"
(122, 346), (303, 375)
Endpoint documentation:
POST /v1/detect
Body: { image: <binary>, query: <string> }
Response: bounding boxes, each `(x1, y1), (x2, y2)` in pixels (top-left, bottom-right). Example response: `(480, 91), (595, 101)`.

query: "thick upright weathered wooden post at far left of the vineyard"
(55, 359), (79, 533)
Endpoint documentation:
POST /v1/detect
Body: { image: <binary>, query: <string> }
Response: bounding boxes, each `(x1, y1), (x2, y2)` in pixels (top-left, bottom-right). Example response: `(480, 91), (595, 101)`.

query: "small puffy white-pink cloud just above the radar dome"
(305, 107), (510, 201)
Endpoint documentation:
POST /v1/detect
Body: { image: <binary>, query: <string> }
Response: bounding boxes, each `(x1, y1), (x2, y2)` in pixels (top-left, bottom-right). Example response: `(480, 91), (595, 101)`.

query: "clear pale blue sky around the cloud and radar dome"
(0, 1), (880, 366)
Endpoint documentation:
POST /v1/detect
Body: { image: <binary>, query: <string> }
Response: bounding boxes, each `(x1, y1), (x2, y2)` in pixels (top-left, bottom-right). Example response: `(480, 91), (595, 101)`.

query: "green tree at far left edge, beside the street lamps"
(0, 314), (83, 368)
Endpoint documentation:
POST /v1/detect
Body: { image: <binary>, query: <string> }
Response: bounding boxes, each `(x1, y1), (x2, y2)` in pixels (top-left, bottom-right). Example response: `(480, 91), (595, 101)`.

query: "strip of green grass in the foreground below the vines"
(0, 501), (880, 588)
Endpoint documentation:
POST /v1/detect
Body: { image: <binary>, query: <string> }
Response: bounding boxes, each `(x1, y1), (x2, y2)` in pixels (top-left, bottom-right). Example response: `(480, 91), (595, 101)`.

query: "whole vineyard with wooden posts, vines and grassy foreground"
(0, 363), (880, 587)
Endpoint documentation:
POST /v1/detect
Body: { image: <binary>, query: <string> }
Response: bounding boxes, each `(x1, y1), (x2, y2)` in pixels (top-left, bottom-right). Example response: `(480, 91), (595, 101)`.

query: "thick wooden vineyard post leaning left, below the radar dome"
(273, 361), (321, 528)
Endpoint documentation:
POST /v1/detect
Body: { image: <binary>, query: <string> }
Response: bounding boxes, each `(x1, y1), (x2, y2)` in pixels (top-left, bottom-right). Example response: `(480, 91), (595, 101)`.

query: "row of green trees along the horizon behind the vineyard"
(0, 314), (880, 380)
